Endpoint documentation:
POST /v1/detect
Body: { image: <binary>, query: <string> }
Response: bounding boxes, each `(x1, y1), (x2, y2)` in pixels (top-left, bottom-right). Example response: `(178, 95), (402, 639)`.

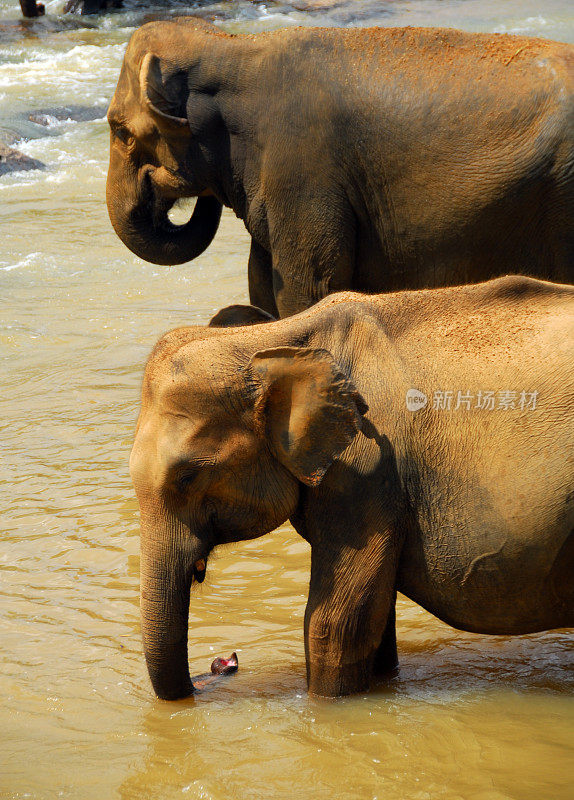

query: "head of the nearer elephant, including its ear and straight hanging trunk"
(130, 322), (367, 699)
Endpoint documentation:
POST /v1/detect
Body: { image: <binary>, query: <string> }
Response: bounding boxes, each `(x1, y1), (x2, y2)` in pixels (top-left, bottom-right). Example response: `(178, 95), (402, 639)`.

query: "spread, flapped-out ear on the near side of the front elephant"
(250, 347), (368, 486)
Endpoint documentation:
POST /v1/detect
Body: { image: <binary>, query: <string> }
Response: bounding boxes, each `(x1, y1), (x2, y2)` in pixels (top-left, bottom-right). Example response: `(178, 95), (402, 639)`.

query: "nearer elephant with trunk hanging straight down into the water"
(130, 277), (574, 699)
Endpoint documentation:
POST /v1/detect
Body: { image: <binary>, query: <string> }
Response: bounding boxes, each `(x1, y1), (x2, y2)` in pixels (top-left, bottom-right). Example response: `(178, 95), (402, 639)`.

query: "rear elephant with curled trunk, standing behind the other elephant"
(107, 20), (574, 316)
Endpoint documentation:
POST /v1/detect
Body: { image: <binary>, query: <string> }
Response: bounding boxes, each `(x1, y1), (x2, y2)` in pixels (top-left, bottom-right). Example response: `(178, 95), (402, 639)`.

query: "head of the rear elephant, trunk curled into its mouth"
(106, 20), (222, 264)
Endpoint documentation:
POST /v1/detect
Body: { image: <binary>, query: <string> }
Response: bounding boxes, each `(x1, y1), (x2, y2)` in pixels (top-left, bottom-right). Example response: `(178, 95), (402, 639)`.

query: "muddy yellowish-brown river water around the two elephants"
(0, 0), (574, 800)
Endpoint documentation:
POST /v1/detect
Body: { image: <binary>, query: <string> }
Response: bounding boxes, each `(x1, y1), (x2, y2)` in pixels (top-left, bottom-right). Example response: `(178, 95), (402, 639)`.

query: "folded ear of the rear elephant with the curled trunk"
(140, 53), (188, 128)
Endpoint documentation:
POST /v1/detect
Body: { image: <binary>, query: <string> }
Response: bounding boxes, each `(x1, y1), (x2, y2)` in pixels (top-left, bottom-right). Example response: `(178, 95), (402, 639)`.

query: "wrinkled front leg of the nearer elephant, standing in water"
(305, 533), (399, 697)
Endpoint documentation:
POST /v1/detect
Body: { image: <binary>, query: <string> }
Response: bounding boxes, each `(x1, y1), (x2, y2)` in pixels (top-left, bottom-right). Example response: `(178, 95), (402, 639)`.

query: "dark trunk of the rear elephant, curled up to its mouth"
(107, 168), (223, 265)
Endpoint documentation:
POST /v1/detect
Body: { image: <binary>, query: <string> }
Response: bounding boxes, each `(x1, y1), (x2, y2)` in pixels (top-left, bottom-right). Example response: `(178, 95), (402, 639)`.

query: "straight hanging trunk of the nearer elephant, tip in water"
(140, 536), (194, 700)
